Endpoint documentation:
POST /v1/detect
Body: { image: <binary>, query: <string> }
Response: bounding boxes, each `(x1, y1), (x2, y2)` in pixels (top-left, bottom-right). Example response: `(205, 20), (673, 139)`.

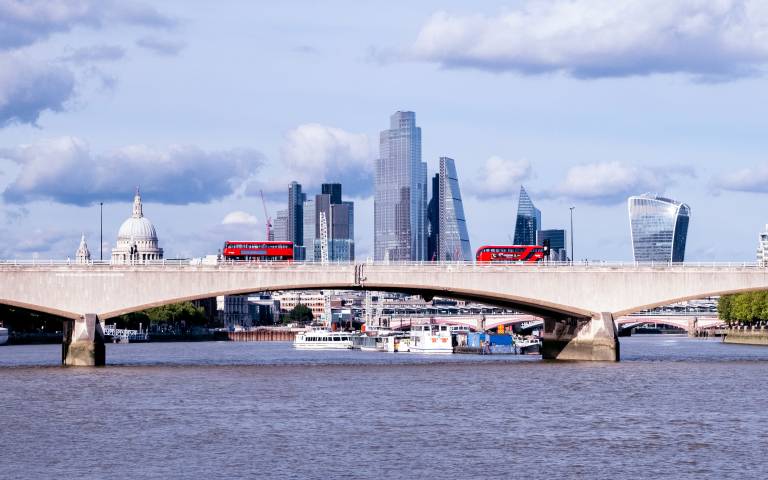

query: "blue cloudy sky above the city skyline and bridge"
(0, 0), (768, 262)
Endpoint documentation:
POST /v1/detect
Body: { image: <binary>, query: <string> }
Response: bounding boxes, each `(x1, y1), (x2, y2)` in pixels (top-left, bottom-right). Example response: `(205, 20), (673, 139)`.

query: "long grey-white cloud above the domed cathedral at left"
(0, 137), (263, 205)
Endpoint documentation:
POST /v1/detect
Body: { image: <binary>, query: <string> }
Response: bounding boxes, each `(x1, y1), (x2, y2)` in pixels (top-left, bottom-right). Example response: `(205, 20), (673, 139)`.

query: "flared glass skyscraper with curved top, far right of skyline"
(628, 193), (691, 262)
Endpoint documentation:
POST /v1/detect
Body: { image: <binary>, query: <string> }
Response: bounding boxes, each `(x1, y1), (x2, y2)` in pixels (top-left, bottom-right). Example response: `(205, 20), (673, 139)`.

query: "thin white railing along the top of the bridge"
(0, 259), (768, 272)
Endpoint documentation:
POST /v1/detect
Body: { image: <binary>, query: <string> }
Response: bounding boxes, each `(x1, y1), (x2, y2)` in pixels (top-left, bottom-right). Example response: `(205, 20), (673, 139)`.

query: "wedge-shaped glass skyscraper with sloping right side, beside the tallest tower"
(437, 157), (472, 261)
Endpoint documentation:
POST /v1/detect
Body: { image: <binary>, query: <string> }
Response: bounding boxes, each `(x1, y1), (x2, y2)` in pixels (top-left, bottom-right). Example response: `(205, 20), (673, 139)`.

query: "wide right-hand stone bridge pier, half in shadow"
(541, 312), (620, 362)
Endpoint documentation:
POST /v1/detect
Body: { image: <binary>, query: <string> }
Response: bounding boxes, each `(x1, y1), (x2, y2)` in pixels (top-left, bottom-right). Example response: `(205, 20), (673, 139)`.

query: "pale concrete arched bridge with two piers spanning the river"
(0, 261), (768, 365)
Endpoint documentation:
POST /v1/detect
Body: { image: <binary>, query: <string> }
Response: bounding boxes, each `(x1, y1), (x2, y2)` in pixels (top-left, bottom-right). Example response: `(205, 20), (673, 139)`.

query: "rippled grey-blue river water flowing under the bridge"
(0, 336), (768, 480)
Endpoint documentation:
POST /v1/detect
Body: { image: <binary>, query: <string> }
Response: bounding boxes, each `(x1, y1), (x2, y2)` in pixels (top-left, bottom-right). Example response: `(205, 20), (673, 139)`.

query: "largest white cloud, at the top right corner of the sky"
(411, 0), (768, 78)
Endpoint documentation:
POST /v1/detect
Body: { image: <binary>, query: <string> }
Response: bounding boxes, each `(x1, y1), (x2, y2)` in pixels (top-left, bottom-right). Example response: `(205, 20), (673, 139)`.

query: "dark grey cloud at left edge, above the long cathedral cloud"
(0, 55), (75, 127)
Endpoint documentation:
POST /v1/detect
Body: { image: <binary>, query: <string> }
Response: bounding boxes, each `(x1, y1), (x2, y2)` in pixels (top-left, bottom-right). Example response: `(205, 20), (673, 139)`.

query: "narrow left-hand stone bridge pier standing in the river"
(61, 313), (106, 367)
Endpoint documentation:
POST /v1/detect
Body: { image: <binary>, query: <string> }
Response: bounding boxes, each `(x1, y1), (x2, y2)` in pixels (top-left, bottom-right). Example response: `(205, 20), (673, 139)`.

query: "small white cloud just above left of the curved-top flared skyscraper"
(549, 162), (692, 204)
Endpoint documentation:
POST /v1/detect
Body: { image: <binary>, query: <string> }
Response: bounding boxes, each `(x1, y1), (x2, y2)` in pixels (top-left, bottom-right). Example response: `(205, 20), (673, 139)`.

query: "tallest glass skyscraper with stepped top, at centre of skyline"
(373, 111), (427, 261)
